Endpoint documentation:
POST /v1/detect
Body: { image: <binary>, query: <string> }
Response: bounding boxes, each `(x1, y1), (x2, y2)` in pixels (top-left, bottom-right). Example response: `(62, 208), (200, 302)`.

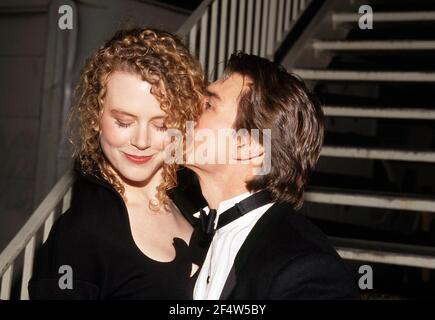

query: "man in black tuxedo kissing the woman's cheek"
(187, 53), (358, 299)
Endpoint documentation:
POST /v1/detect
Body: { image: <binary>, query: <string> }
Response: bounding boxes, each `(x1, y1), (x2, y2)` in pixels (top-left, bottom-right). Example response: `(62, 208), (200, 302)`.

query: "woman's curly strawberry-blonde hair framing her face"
(68, 28), (206, 210)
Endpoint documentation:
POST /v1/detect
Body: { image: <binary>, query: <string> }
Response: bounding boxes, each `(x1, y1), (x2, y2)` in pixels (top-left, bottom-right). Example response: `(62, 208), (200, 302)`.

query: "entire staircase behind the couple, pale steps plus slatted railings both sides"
(0, 0), (435, 299)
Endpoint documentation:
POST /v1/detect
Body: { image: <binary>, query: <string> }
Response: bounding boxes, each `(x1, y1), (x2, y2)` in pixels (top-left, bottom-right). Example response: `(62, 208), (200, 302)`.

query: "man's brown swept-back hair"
(224, 52), (324, 208)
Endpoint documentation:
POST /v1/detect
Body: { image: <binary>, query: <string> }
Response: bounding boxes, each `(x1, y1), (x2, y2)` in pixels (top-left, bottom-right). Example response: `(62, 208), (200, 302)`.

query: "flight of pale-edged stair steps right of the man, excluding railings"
(280, 0), (435, 296)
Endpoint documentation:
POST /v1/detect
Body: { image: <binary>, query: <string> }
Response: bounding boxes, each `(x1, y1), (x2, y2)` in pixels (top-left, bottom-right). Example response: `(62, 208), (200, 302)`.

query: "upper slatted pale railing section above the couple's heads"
(177, 0), (311, 80)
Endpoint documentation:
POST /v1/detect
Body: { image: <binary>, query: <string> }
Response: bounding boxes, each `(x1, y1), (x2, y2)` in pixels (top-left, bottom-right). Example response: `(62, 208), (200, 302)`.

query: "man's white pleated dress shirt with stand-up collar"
(193, 192), (273, 300)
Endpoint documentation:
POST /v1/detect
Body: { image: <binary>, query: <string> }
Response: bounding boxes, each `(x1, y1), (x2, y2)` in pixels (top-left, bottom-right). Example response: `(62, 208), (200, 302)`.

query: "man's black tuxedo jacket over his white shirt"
(216, 203), (359, 300)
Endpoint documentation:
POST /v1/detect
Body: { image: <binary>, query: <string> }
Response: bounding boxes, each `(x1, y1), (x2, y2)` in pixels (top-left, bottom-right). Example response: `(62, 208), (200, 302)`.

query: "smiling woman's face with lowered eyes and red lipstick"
(100, 71), (166, 184)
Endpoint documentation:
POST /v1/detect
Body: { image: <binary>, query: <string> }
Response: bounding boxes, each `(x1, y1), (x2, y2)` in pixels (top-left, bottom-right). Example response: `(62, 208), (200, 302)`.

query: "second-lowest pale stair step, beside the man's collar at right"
(305, 188), (435, 212)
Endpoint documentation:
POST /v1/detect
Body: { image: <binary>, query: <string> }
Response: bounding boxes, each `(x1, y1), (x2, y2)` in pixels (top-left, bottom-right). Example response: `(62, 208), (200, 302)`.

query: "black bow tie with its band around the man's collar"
(199, 190), (273, 236)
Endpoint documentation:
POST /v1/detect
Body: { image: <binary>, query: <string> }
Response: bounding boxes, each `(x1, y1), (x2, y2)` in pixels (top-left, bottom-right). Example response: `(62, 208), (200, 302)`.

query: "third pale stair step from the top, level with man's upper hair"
(292, 69), (435, 82)
